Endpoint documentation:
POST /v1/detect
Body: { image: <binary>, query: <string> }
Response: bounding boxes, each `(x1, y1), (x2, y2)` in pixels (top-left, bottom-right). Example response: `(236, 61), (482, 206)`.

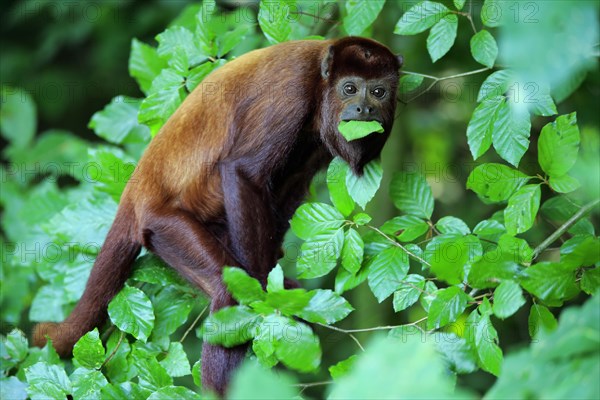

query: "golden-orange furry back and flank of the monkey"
(122, 40), (330, 228)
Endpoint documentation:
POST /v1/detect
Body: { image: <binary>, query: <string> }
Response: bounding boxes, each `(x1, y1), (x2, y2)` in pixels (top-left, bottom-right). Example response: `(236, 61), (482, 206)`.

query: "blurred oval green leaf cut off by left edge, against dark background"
(0, 86), (37, 149)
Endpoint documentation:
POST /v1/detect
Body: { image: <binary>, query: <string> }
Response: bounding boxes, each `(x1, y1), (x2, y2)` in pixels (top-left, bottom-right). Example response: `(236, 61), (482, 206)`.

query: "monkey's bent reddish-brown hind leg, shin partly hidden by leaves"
(143, 211), (247, 395)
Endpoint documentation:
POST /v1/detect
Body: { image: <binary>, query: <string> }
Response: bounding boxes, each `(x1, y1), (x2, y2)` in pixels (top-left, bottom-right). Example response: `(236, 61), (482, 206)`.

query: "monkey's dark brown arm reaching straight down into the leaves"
(219, 160), (280, 283)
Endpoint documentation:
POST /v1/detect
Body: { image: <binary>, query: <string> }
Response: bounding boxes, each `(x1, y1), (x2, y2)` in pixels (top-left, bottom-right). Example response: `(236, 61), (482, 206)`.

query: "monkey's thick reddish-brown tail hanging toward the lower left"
(33, 204), (141, 357)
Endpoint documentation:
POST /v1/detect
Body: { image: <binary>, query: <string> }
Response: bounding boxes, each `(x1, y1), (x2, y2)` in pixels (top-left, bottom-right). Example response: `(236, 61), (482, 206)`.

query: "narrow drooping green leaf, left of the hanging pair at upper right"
(467, 96), (504, 160)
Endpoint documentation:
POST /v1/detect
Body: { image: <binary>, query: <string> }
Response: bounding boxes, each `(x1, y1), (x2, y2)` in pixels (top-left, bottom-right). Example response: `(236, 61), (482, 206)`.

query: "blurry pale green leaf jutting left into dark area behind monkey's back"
(88, 96), (150, 144)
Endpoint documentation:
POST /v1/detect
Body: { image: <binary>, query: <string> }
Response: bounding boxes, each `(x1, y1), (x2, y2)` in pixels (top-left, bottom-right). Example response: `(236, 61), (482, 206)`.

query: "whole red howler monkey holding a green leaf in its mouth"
(34, 37), (402, 394)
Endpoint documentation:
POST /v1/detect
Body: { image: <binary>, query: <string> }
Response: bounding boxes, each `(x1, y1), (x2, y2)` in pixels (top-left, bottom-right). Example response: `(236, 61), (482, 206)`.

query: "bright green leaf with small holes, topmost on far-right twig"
(538, 113), (579, 176)
